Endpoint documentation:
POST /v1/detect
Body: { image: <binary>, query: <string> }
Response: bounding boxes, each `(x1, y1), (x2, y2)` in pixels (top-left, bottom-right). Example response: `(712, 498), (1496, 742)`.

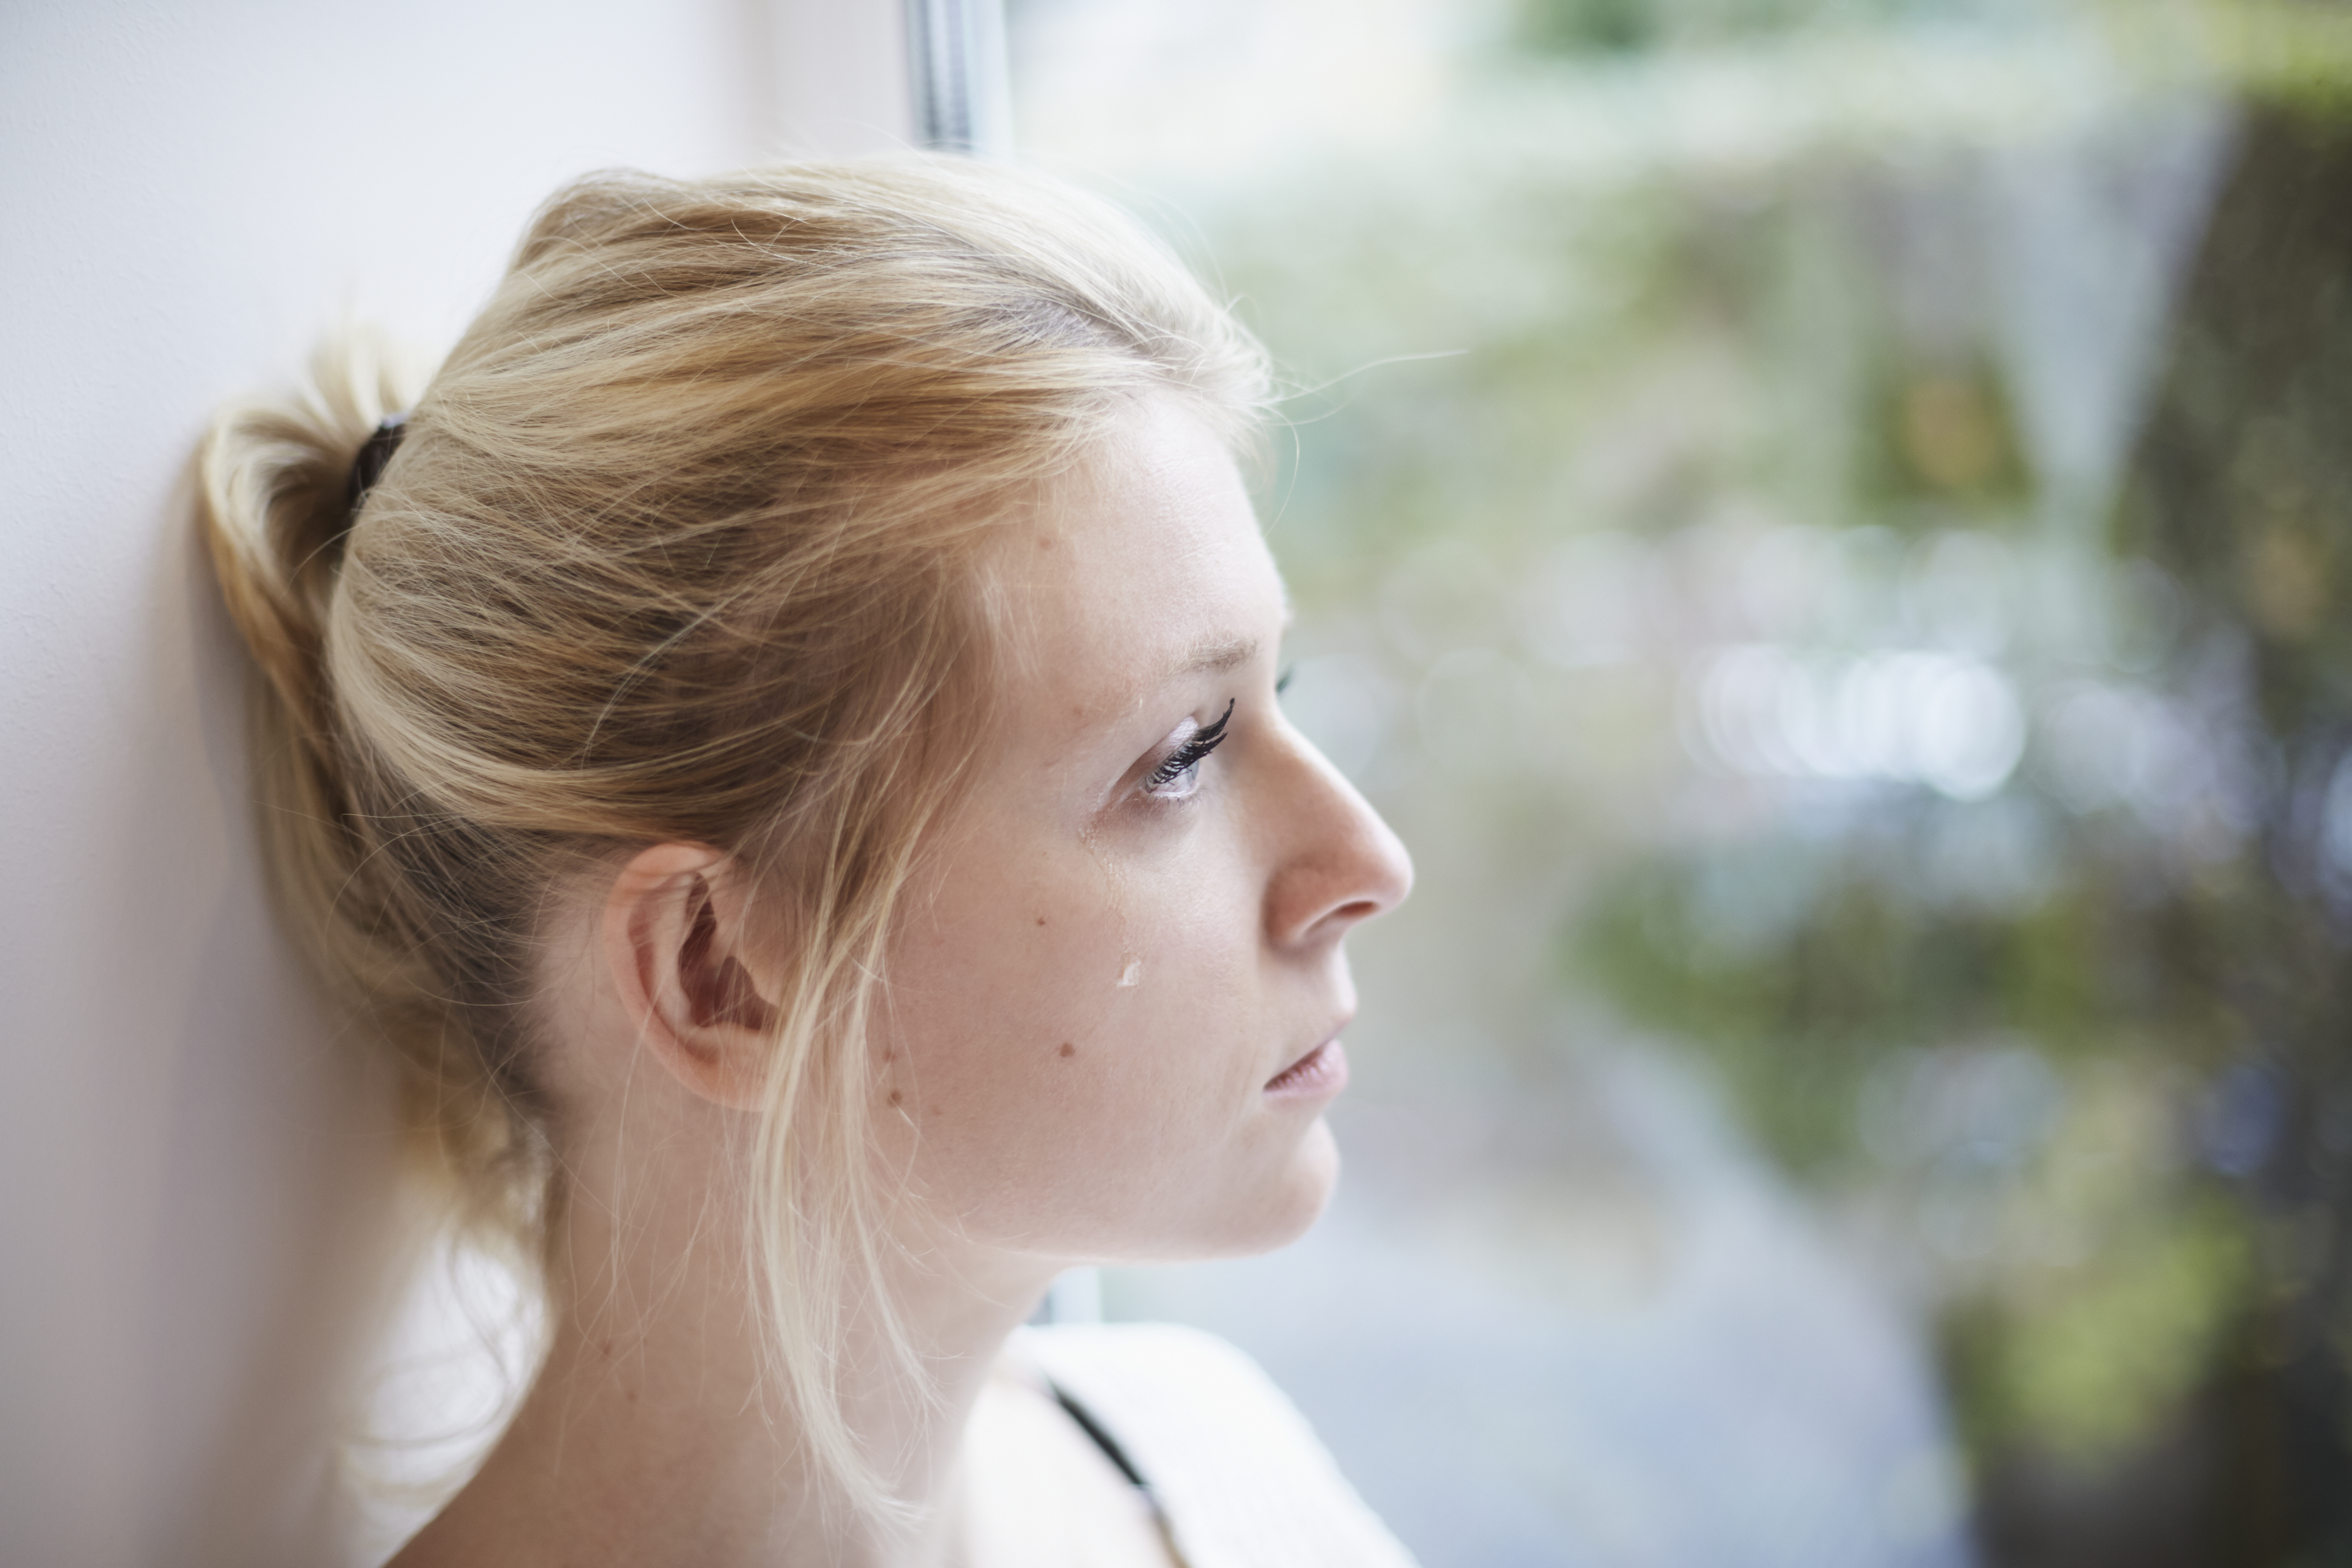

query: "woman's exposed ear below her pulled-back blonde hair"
(602, 844), (776, 1109)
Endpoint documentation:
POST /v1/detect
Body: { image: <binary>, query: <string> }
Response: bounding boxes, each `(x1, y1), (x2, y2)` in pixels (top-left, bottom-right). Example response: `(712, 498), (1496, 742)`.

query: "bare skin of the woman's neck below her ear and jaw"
(400, 1175), (1054, 1568)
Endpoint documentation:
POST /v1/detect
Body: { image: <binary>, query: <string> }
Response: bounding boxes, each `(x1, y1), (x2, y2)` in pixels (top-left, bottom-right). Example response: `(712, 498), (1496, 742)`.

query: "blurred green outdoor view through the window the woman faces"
(1009, 0), (2352, 1568)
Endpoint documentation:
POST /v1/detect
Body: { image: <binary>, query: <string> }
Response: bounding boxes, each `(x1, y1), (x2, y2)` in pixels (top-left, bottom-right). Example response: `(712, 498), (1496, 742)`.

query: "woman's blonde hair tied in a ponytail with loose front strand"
(200, 160), (1265, 1507)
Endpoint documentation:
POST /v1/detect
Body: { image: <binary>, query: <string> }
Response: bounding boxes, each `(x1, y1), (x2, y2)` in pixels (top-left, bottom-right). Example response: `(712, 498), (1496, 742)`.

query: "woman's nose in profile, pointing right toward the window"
(1265, 724), (1414, 947)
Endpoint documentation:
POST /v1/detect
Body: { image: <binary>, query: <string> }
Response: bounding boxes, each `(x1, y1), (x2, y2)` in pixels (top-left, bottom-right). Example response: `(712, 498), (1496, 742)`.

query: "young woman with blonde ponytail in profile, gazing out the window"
(202, 160), (1409, 1568)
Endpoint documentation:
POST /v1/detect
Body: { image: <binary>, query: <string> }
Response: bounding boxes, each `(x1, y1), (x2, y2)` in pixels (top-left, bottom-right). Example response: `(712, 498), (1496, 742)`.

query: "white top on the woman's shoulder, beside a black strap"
(1007, 1323), (1414, 1568)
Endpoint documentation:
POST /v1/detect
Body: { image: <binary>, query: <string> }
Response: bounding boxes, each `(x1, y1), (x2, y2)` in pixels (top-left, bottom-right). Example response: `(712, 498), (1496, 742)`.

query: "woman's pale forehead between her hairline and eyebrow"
(997, 397), (1284, 710)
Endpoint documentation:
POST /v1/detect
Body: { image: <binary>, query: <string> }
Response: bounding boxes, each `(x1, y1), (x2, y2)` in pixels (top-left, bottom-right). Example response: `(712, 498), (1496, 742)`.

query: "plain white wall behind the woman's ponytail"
(0, 0), (908, 1568)
